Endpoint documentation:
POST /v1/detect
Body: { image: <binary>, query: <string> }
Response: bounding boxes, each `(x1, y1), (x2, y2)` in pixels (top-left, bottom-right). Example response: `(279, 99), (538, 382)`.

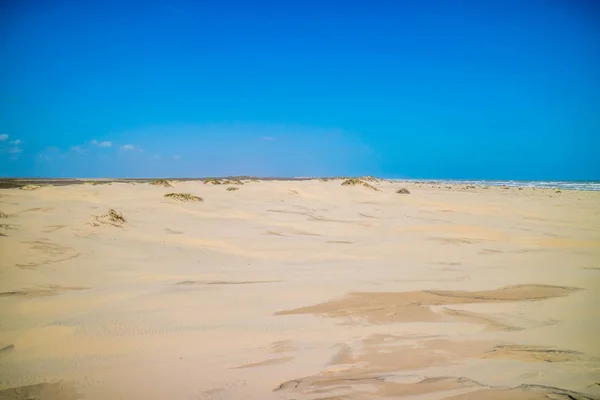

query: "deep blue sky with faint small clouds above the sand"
(0, 0), (600, 180)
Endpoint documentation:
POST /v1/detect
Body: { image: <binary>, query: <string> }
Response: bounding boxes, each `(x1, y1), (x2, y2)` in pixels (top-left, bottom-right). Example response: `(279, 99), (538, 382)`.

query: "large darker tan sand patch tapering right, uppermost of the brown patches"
(275, 285), (579, 323)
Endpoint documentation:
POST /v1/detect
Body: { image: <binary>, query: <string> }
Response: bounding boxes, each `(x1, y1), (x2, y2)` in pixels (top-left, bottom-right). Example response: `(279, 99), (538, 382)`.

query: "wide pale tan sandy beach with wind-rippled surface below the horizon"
(0, 179), (600, 400)
